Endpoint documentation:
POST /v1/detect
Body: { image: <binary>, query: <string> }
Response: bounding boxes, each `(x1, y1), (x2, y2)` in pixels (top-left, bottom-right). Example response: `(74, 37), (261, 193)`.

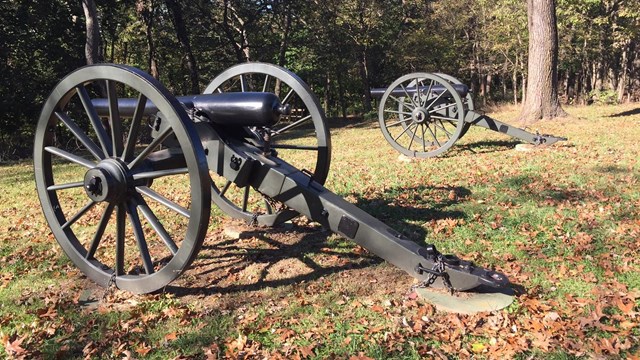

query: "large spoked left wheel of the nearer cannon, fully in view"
(34, 64), (211, 293)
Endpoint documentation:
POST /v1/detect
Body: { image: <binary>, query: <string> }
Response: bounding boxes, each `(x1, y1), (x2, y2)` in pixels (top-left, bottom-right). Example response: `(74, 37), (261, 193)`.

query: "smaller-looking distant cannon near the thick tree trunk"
(371, 72), (566, 158)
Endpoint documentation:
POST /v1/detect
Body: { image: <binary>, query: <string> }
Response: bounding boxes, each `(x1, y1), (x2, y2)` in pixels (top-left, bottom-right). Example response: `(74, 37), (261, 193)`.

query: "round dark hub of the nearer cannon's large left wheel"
(84, 159), (130, 202)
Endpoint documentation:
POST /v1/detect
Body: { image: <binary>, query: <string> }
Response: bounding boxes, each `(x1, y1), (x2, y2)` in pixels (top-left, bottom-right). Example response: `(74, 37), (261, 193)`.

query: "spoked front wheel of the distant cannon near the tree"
(378, 73), (465, 158)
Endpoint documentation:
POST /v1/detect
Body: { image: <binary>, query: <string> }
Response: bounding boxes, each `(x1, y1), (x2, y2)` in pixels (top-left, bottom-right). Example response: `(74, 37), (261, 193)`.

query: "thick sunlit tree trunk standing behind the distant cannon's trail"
(520, 0), (567, 124)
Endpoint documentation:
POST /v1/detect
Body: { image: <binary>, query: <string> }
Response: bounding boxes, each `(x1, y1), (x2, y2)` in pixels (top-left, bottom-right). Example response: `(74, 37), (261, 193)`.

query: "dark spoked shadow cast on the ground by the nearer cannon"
(165, 186), (470, 301)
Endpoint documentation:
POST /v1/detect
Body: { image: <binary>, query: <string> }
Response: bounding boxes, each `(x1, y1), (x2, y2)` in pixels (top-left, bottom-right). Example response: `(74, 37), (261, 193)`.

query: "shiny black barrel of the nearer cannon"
(91, 92), (287, 126)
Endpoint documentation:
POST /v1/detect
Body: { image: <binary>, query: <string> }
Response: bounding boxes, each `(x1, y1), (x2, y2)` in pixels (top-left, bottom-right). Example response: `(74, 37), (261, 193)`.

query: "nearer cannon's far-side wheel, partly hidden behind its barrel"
(204, 63), (331, 226)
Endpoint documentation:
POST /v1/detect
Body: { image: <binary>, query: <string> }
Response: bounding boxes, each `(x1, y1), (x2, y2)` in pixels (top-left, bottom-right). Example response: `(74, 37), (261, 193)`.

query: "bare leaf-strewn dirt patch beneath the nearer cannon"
(79, 218), (414, 312)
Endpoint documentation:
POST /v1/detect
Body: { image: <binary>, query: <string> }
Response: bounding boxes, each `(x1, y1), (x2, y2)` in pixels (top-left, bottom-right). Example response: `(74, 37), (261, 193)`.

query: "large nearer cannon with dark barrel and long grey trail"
(34, 63), (509, 293)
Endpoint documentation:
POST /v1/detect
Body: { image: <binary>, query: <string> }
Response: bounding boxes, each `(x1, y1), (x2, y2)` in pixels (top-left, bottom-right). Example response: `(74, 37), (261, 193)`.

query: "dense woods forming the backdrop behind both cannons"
(0, 0), (640, 158)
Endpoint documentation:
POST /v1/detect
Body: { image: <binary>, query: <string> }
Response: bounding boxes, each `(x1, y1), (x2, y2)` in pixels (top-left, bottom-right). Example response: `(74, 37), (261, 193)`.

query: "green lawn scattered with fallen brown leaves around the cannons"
(0, 104), (640, 359)
